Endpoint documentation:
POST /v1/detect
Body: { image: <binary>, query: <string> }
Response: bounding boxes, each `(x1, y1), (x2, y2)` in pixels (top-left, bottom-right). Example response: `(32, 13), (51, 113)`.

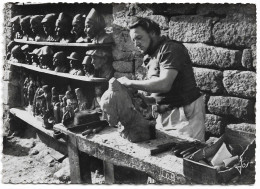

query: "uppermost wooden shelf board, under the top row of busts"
(14, 39), (113, 49)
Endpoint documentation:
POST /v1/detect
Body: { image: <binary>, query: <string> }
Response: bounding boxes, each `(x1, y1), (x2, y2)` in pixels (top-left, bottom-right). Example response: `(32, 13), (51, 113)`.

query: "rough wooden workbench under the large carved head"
(54, 124), (194, 184)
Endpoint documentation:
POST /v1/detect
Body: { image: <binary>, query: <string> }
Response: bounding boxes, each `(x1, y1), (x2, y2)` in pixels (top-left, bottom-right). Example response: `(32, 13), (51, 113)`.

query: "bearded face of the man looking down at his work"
(130, 26), (152, 54)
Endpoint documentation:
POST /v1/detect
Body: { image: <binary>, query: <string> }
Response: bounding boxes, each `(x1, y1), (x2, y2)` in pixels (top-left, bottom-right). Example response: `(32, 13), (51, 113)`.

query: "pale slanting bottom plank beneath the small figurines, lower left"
(10, 108), (54, 137)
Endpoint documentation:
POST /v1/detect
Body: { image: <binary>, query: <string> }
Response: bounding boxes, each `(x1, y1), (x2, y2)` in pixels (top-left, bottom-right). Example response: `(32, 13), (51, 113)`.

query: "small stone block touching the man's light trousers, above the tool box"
(205, 114), (227, 136)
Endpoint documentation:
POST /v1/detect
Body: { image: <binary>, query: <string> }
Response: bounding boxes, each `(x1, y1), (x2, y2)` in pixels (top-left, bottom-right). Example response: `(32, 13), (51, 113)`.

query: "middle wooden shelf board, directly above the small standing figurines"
(8, 61), (107, 82)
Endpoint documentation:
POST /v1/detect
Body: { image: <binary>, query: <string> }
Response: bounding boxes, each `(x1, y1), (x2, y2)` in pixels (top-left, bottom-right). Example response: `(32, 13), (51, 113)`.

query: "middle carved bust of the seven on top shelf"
(41, 13), (57, 41)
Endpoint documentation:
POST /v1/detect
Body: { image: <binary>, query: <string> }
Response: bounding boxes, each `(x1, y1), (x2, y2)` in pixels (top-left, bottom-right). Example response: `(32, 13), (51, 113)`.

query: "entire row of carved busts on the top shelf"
(10, 8), (113, 43)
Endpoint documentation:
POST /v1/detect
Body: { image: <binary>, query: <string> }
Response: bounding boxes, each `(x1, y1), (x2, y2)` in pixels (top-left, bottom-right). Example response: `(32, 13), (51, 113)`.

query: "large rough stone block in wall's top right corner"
(212, 14), (256, 48)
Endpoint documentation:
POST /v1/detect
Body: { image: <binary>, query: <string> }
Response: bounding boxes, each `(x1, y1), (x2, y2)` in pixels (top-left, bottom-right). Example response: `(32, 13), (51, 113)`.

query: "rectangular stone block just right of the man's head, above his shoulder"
(169, 16), (213, 43)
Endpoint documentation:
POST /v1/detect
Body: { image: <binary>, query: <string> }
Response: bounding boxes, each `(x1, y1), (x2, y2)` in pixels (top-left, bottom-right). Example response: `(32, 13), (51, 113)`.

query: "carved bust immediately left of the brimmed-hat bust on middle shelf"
(53, 51), (69, 73)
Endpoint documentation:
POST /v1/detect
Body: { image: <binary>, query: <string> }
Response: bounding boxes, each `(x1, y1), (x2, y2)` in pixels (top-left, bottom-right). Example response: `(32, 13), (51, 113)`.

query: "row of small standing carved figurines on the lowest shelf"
(23, 76), (103, 128)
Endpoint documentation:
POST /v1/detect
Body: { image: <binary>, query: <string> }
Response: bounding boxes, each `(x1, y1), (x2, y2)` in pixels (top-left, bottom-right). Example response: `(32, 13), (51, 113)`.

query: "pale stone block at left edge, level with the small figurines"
(2, 81), (21, 108)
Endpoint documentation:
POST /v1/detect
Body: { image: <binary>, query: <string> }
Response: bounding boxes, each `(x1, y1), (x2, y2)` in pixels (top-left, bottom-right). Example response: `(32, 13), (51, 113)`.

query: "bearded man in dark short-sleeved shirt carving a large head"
(119, 18), (205, 141)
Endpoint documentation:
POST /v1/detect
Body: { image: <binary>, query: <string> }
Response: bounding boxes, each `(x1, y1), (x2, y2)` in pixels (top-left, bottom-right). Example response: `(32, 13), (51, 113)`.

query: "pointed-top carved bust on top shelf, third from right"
(55, 12), (73, 43)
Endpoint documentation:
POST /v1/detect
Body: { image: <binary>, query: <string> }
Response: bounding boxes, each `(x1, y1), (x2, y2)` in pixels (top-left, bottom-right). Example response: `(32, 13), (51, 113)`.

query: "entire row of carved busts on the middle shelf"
(7, 41), (114, 79)
